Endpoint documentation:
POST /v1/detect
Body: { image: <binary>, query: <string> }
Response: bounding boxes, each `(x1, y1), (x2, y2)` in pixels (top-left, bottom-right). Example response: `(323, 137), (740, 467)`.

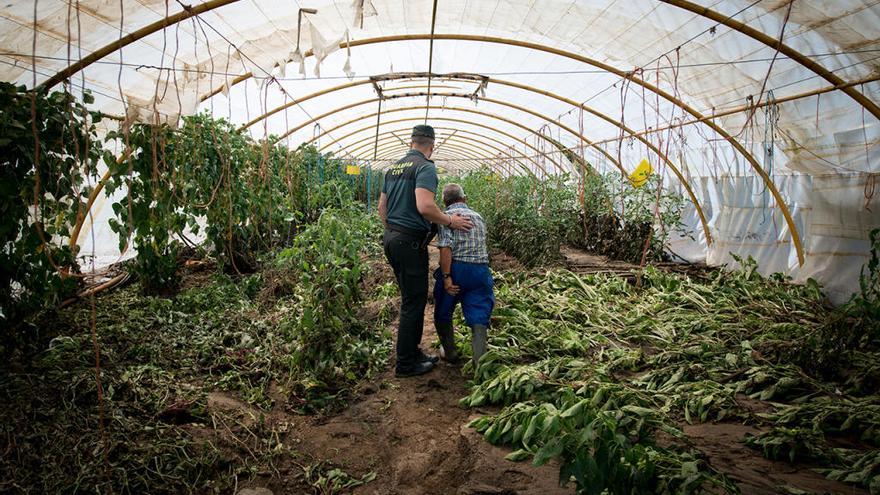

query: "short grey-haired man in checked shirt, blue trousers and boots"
(434, 184), (495, 366)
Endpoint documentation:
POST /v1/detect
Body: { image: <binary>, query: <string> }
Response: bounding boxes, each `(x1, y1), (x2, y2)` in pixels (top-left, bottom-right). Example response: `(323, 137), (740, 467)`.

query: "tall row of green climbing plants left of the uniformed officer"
(107, 114), (379, 293)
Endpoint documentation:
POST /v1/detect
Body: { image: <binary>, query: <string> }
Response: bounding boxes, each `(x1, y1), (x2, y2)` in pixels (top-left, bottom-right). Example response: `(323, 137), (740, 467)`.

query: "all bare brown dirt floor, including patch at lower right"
(229, 250), (867, 495)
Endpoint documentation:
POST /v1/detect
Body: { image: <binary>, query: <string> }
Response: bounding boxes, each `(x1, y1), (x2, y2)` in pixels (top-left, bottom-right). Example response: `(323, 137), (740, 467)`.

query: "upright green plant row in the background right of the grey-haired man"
(444, 170), (684, 267)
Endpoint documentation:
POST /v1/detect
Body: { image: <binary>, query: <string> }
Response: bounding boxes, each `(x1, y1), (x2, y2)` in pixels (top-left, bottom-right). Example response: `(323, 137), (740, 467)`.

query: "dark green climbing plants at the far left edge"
(0, 82), (102, 323)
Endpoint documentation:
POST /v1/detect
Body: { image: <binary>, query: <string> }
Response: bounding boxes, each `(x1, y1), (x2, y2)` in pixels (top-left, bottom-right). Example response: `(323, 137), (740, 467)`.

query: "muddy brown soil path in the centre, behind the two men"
(230, 249), (574, 495)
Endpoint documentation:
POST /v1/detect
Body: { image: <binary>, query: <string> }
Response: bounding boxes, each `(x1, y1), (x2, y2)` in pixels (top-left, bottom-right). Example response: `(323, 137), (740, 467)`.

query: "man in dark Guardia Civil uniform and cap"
(379, 125), (473, 377)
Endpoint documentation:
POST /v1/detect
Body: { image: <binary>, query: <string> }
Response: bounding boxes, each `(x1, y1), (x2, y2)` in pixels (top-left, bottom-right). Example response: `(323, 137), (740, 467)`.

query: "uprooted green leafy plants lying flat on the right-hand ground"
(462, 246), (880, 494)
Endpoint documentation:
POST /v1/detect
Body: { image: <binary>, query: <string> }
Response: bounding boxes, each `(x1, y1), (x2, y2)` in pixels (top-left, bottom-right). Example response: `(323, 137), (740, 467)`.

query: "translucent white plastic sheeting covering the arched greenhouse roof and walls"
(0, 0), (880, 302)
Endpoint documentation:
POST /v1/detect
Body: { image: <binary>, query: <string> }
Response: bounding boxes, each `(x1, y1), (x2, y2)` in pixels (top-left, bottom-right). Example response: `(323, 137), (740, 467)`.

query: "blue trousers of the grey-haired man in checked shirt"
(434, 261), (495, 327)
